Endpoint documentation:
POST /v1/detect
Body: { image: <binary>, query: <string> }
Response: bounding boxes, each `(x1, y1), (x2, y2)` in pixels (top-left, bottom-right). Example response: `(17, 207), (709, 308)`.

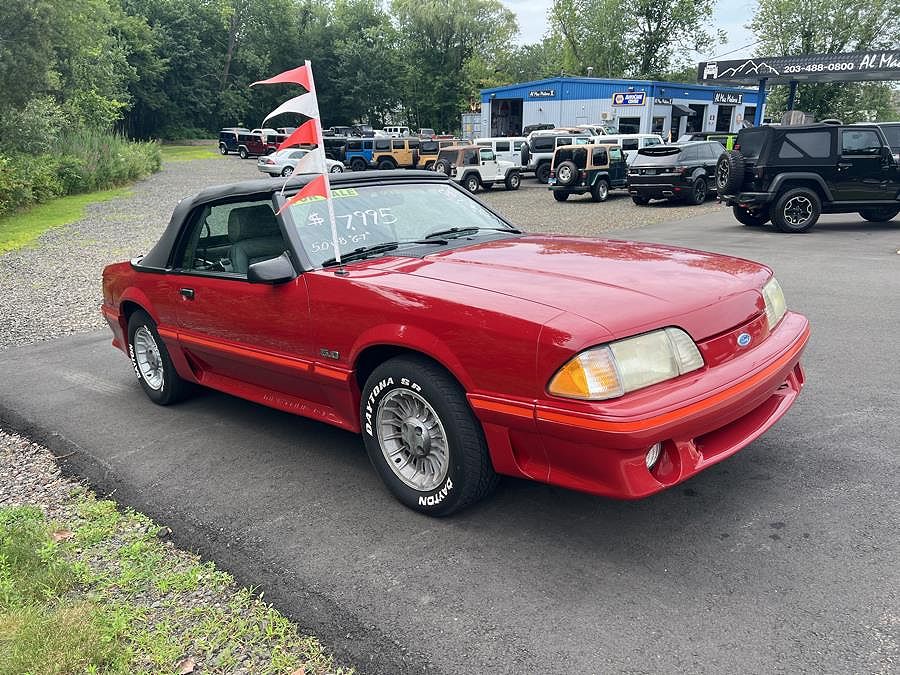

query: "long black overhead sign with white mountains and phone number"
(697, 50), (900, 86)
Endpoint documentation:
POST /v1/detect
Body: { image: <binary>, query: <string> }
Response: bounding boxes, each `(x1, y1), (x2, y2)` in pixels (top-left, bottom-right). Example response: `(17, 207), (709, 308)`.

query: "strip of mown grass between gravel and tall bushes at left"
(0, 188), (130, 254)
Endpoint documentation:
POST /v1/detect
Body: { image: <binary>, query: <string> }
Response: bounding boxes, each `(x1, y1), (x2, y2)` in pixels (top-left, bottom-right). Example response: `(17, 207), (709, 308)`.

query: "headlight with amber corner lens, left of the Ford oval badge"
(548, 328), (703, 401)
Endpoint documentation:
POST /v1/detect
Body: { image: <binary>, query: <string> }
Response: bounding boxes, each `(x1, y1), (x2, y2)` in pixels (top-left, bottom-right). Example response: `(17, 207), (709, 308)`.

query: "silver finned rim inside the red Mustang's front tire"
(375, 389), (450, 492)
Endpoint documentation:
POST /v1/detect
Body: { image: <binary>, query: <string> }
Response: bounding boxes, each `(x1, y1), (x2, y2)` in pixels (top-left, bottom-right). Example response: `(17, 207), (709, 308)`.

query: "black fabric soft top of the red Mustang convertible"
(134, 169), (449, 269)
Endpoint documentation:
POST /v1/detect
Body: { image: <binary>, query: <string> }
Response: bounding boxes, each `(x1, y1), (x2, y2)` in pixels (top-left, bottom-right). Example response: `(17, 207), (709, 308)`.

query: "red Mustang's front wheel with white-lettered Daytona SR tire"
(360, 356), (497, 516)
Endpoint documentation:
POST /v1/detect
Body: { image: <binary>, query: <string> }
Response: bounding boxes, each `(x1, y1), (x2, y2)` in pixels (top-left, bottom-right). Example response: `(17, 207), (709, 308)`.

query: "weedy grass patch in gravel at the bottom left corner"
(0, 493), (351, 675)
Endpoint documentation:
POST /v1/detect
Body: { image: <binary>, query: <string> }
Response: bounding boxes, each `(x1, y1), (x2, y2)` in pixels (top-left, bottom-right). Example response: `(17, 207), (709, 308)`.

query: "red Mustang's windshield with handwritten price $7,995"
(291, 183), (512, 267)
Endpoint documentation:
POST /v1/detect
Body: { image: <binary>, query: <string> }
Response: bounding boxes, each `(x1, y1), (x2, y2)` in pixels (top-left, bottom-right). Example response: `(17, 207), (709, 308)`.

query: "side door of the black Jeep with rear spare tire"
(832, 127), (890, 201)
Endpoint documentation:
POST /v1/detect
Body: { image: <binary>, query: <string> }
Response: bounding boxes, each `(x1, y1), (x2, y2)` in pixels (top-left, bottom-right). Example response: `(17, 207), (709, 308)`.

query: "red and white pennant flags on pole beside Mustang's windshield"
(250, 61), (341, 264)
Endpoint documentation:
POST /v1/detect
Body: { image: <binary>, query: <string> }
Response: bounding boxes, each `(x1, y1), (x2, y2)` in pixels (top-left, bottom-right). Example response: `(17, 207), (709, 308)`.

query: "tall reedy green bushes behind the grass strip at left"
(0, 129), (162, 215)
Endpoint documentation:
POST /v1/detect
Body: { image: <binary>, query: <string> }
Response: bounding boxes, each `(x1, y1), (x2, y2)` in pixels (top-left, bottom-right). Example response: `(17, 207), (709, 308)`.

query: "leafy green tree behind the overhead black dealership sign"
(748, 0), (900, 122)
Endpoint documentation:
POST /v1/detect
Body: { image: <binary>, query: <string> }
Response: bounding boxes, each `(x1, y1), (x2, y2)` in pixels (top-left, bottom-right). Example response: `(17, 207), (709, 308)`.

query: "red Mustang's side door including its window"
(172, 199), (322, 405)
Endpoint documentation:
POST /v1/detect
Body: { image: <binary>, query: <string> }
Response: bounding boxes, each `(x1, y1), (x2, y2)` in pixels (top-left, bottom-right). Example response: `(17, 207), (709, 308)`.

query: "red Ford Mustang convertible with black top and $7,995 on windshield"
(103, 171), (809, 515)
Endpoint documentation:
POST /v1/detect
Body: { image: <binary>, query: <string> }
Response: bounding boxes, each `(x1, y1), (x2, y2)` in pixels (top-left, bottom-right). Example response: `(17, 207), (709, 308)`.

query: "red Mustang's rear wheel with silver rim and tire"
(128, 310), (189, 405)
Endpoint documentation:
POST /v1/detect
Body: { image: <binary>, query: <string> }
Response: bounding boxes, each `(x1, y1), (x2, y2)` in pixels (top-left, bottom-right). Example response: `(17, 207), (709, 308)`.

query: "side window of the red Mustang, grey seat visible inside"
(181, 199), (287, 276)
